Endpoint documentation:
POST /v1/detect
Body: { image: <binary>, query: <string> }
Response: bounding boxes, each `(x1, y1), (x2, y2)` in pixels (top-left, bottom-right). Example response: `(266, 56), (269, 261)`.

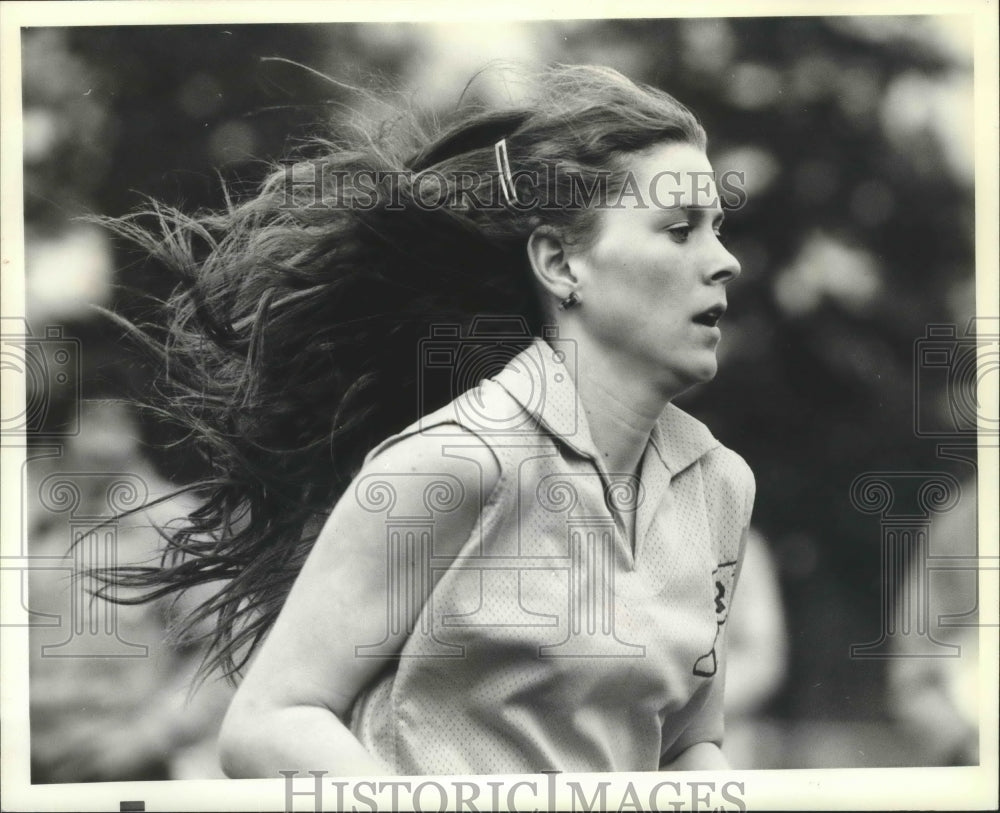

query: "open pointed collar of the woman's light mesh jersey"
(493, 338), (721, 475)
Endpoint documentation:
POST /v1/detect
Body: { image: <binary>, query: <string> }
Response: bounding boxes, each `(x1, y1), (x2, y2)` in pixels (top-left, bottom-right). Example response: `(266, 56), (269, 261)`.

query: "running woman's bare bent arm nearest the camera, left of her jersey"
(220, 427), (500, 777)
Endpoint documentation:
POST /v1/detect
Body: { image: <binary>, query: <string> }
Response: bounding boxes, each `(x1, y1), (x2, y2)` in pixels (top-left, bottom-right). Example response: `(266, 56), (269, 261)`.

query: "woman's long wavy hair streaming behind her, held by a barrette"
(99, 61), (705, 678)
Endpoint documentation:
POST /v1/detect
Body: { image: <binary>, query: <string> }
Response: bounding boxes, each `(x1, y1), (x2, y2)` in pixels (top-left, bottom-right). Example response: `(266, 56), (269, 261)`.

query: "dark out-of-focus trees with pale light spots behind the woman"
(23, 17), (975, 765)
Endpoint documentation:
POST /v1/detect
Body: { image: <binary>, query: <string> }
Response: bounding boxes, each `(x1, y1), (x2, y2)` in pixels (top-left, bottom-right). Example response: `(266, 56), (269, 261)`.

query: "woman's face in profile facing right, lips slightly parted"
(568, 144), (740, 397)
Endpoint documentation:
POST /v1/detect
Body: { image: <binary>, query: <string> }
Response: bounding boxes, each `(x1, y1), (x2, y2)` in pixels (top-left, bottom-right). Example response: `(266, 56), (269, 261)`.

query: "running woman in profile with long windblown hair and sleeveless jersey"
(105, 61), (753, 777)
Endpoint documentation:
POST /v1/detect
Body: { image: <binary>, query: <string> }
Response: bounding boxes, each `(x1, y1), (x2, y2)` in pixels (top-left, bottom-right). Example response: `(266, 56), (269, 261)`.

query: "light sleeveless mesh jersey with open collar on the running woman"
(350, 339), (754, 775)
